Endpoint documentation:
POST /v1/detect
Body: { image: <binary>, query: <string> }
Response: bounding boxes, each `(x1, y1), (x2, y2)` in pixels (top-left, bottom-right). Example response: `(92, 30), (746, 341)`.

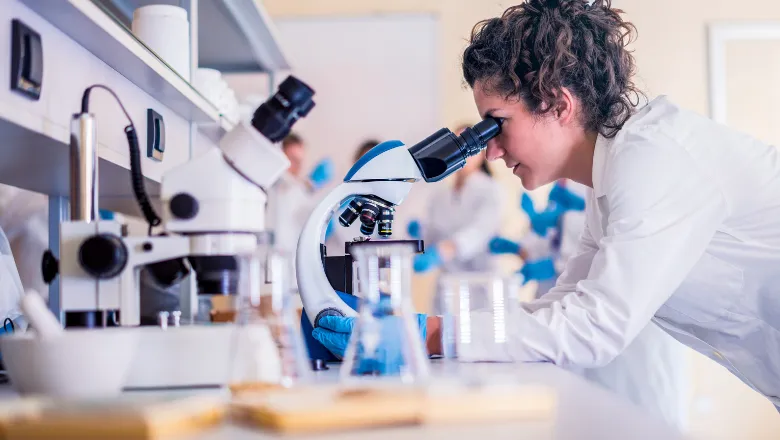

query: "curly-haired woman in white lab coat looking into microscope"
(463, 0), (780, 405)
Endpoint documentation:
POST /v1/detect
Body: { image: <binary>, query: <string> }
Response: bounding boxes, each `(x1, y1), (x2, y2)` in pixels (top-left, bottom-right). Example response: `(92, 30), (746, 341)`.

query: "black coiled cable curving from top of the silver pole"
(81, 84), (162, 235)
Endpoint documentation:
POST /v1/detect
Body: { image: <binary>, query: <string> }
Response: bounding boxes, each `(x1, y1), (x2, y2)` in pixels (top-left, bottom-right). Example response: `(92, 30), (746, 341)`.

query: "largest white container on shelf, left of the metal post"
(132, 5), (190, 81)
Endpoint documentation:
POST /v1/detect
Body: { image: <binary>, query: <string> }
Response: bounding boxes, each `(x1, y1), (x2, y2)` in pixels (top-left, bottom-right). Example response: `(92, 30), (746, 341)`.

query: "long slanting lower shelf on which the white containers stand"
(21, 0), (221, 141)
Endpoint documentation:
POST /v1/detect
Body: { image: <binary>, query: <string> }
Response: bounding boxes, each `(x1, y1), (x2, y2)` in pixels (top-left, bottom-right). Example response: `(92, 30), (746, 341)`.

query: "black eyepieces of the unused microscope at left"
(252, 76), (314, 142)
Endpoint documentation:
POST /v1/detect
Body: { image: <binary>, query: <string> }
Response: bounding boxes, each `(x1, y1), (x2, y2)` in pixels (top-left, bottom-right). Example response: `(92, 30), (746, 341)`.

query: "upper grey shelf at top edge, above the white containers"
(89, 0), (290, 72)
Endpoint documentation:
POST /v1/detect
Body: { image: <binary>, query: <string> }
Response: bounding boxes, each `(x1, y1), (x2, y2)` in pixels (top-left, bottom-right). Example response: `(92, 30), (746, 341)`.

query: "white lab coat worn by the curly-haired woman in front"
(466, 97), (780, 405)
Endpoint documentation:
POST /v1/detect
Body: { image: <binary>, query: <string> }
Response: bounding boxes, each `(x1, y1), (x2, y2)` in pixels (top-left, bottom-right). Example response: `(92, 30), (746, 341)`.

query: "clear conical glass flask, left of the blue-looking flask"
(228, 248), (310, 392)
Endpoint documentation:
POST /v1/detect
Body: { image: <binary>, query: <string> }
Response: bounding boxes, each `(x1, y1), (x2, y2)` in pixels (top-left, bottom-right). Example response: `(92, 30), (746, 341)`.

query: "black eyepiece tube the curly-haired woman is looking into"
(409, 117), (501, 182)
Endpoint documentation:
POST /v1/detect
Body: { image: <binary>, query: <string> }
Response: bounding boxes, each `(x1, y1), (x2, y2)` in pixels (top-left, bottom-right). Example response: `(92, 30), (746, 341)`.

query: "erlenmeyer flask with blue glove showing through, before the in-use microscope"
(340, 242), (428, 383)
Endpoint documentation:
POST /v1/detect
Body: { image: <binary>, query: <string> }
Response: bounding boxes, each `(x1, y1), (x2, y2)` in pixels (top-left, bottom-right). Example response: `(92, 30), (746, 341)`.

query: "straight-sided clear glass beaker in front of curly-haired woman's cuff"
(441, 272), (521, 362)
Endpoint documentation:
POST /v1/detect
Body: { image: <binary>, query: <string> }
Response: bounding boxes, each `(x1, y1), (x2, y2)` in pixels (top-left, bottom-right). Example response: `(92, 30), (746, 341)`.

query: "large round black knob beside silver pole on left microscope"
(79, 234), (127, 279)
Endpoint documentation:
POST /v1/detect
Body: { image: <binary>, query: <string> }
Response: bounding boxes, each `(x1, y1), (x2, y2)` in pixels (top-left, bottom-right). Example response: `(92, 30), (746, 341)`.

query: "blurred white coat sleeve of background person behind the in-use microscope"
(452, 185), (501, 261)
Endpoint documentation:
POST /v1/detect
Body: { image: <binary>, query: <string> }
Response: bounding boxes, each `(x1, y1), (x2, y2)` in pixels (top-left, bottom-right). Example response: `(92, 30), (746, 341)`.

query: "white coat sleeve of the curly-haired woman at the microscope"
(460, 139), (728, 367)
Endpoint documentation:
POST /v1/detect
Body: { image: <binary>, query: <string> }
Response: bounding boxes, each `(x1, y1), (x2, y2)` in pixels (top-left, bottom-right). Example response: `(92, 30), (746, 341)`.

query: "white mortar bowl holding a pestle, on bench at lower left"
(0, 329), (138, 399)
